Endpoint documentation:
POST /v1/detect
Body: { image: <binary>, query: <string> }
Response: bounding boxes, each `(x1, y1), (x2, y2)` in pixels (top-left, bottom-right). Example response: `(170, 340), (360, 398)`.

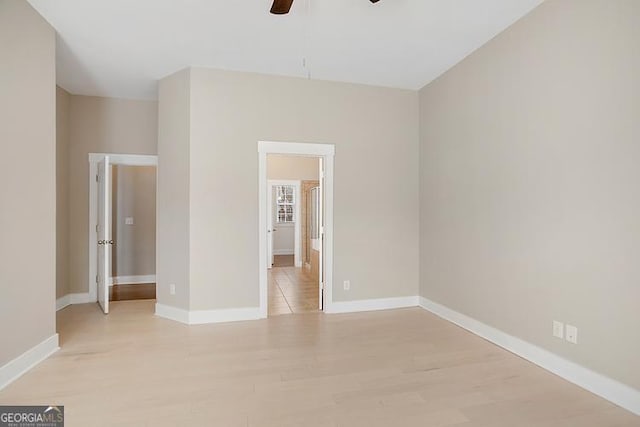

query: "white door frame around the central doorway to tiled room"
(258, 141), (335, 318)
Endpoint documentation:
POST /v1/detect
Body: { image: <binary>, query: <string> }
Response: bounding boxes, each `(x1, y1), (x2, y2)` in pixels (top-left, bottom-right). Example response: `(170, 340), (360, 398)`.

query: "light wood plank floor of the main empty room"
(0, 301), (640, 427)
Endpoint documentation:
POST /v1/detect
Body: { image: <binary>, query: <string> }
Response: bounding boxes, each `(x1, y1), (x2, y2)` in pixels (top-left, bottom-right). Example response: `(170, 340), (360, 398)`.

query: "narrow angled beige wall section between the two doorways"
(156, 70), (191, 309)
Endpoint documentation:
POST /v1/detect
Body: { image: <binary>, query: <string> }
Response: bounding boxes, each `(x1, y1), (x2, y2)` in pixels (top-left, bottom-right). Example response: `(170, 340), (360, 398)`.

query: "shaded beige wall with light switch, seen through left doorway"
(112, 165), (156, 276)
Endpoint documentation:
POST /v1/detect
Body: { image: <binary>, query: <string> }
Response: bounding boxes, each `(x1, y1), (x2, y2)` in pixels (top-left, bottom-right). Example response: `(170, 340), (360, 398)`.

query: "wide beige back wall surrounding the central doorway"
(186, 68), (418, 310)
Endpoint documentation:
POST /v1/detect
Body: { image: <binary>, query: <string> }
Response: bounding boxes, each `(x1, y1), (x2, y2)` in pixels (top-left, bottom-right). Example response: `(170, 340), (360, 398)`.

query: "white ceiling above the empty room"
(29, 0), (543, 99)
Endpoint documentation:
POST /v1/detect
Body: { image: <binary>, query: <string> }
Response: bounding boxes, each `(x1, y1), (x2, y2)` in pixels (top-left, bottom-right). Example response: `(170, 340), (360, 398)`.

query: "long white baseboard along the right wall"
(420, 297), (640, 415)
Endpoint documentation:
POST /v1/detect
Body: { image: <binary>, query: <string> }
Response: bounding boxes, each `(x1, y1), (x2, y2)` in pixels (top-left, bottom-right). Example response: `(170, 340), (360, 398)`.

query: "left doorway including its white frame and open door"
(89, 153), (157, 314)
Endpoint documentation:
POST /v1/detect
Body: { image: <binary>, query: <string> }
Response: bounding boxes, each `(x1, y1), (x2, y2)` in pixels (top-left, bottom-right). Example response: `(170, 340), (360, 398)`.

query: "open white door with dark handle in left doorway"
(96, 156), (113, 314)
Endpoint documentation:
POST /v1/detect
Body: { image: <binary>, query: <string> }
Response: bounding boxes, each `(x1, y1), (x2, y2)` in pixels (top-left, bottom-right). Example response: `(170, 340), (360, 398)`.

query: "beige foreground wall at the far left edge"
(0, 0), (56, 367)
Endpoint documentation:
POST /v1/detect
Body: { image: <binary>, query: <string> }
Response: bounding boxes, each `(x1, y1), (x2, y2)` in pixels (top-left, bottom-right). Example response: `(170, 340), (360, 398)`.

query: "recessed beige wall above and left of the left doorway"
(69, 95), (158, 293)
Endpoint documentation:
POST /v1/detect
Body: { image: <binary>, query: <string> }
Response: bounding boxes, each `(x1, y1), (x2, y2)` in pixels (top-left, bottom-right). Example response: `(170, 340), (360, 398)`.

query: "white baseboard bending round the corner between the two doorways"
(156, 303), (262, 325)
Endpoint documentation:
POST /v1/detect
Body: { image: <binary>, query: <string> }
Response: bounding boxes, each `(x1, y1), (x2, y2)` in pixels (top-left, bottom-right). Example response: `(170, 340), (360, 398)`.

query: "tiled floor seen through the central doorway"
(267, 264), (319, 316)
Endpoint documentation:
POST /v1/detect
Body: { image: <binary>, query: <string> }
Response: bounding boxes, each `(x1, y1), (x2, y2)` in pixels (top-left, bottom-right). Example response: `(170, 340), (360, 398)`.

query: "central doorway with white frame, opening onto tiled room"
(258, 142), (334, 317)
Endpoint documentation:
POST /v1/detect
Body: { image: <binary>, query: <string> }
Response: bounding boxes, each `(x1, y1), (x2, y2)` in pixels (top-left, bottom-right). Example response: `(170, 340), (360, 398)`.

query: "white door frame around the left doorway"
(88, 153), (158, 302)
